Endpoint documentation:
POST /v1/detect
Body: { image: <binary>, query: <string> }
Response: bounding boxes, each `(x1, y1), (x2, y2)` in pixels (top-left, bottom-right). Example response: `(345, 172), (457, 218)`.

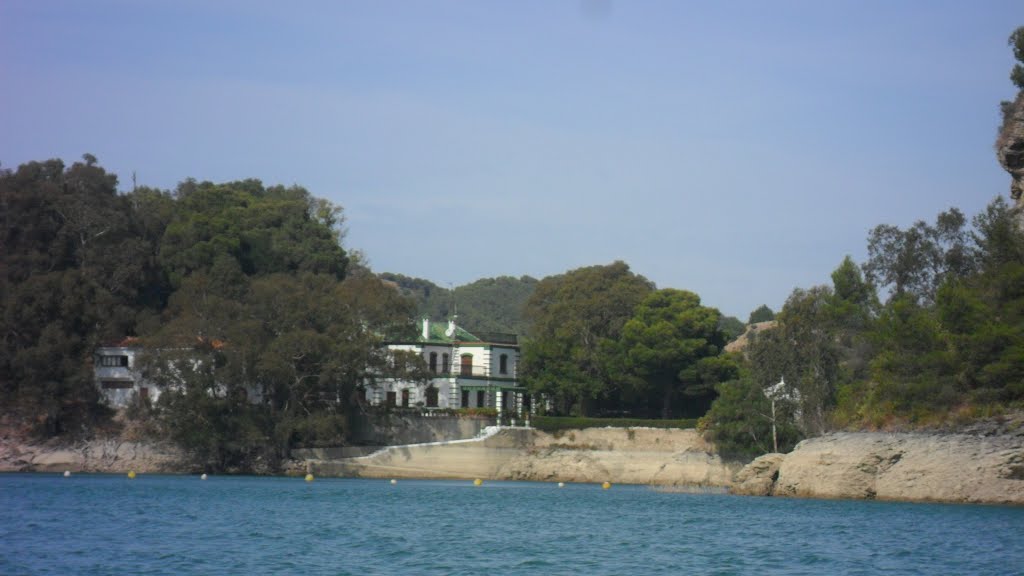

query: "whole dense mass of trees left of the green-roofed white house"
(0, 155), (419, 468)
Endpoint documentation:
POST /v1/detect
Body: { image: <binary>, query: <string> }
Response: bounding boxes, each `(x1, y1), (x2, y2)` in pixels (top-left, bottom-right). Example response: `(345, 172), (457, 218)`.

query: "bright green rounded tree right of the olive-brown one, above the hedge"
(620, 288), (734, 418)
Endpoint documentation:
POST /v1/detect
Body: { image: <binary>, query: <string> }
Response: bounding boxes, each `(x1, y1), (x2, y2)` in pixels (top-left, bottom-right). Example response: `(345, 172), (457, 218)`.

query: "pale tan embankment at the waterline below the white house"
(306, 428), (740, 487)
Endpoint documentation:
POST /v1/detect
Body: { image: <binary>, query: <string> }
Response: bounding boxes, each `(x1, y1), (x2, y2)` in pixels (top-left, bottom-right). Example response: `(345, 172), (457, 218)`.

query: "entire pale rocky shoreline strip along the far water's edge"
(8, 425), (1024, 504)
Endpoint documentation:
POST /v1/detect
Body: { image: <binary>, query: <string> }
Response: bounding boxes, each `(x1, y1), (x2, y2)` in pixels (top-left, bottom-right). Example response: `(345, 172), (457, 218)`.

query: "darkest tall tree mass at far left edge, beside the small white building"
(0, 155), (161, 435)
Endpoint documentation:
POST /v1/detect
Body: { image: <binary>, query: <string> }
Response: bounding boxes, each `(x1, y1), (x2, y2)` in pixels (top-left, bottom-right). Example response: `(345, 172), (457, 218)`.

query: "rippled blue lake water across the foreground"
(0, 475), (1024, 575)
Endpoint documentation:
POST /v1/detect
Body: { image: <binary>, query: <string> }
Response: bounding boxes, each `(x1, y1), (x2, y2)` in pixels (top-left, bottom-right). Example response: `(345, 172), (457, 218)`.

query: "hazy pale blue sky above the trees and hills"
(0, 0), (1024, 321)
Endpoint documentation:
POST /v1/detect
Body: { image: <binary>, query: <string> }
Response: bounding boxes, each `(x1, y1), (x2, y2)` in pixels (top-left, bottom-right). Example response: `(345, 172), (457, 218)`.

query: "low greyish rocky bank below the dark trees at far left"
(0, 437), (185, 474)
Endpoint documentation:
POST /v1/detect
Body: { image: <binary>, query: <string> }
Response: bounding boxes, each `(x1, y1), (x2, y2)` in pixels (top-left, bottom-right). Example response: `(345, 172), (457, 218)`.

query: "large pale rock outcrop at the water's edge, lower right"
(733, 433), (1024, 504)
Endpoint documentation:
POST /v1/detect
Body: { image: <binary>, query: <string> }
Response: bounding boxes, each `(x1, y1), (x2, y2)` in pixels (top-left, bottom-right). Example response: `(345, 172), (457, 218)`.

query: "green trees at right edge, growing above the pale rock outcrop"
(836, 198), (1024, 426)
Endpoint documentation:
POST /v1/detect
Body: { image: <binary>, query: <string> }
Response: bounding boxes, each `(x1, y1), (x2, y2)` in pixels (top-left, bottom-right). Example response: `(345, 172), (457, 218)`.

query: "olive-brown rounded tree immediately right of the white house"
(522, 261), (653, 415)
